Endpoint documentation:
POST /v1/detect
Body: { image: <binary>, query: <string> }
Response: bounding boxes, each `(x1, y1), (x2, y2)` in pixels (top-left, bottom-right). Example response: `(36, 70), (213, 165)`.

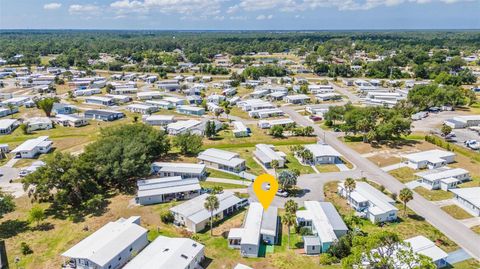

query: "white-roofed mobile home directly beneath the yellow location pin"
(228, 202), (279, 257)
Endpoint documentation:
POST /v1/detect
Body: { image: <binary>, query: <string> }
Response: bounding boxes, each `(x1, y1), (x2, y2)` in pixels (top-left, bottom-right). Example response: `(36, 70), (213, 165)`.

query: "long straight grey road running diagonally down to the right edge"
(281, 106), (480, 260)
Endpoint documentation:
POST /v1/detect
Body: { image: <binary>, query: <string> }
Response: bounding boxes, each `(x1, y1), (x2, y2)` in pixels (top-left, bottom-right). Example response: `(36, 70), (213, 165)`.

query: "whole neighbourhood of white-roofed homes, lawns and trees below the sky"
(0, 29), (480, 269)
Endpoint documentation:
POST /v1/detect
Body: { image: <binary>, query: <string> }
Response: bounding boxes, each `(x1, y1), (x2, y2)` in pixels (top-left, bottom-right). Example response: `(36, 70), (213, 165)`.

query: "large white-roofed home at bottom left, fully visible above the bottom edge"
(62, 218), (148, 267)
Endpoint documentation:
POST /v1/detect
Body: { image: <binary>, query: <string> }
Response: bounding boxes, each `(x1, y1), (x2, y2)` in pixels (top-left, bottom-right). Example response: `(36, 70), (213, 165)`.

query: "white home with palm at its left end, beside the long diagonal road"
(338, 181), (398, 223)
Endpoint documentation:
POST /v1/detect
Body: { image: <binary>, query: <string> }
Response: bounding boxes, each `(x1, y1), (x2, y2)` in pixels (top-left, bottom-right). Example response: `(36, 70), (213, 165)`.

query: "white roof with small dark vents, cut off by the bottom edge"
(123, 236), (205, 269)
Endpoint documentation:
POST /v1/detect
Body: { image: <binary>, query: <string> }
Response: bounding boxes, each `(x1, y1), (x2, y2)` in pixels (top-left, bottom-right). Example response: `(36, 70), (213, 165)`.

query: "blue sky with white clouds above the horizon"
(0, 0), (480, 30)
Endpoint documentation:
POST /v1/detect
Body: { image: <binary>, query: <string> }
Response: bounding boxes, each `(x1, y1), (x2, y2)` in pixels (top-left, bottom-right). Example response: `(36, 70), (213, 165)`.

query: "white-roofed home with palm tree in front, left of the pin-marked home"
(170, 191), (248, 233)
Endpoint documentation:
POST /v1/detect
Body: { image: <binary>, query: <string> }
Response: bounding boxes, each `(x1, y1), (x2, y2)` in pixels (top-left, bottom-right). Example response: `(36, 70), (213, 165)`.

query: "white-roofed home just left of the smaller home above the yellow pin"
(197, 148), (246, 173)
